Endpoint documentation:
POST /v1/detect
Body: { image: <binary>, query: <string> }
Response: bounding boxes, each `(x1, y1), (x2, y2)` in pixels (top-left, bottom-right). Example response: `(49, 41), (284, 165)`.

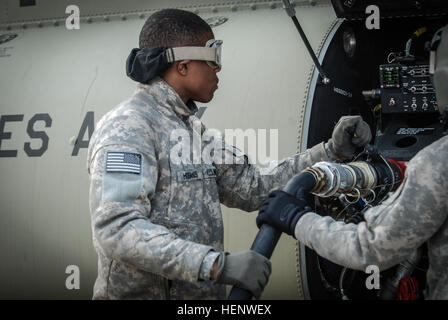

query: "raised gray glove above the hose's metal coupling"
(328, 116), (372, 160)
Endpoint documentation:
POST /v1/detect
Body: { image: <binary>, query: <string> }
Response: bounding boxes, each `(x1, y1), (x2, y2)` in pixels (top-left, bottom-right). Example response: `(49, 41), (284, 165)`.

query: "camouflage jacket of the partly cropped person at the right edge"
(295, 136), (448, 299)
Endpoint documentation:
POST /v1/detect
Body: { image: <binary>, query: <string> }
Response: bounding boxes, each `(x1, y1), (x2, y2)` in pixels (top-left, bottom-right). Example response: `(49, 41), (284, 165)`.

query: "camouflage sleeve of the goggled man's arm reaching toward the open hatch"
(215, 142), (336, 211)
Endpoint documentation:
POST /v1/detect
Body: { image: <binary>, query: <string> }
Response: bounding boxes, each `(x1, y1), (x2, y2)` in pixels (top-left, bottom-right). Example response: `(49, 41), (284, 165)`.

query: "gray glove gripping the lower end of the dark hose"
(216, 250), (271, 299)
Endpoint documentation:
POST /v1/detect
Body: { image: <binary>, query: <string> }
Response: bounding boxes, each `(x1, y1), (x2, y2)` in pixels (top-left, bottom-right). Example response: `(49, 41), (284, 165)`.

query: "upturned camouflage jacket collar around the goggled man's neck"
(139, 77), (198, 117)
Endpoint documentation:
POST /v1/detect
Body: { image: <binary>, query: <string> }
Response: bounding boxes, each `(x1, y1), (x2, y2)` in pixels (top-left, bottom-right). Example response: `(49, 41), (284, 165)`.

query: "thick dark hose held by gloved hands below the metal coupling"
(228, 171), (317, 300)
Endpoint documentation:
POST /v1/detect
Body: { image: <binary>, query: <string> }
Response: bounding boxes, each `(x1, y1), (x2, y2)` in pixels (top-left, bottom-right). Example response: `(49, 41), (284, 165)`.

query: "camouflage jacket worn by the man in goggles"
(88, 78), (331, 299)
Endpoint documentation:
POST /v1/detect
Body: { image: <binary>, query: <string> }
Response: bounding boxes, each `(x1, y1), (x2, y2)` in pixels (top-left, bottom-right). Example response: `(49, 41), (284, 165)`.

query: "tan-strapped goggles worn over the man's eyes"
(165, 39), (222, 69)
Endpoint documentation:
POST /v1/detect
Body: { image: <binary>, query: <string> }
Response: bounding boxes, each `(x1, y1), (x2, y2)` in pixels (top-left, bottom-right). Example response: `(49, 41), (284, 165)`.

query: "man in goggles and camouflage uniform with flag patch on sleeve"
(88, 10), (371, 299)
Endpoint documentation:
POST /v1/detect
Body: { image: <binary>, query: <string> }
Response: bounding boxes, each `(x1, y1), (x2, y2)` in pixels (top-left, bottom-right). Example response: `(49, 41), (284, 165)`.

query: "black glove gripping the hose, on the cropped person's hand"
(257, 190), (312, 237)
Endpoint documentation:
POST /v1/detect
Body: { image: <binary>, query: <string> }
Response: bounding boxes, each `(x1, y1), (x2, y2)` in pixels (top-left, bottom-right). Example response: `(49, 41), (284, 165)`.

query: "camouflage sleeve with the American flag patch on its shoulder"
(90, 144), (212, 282)
